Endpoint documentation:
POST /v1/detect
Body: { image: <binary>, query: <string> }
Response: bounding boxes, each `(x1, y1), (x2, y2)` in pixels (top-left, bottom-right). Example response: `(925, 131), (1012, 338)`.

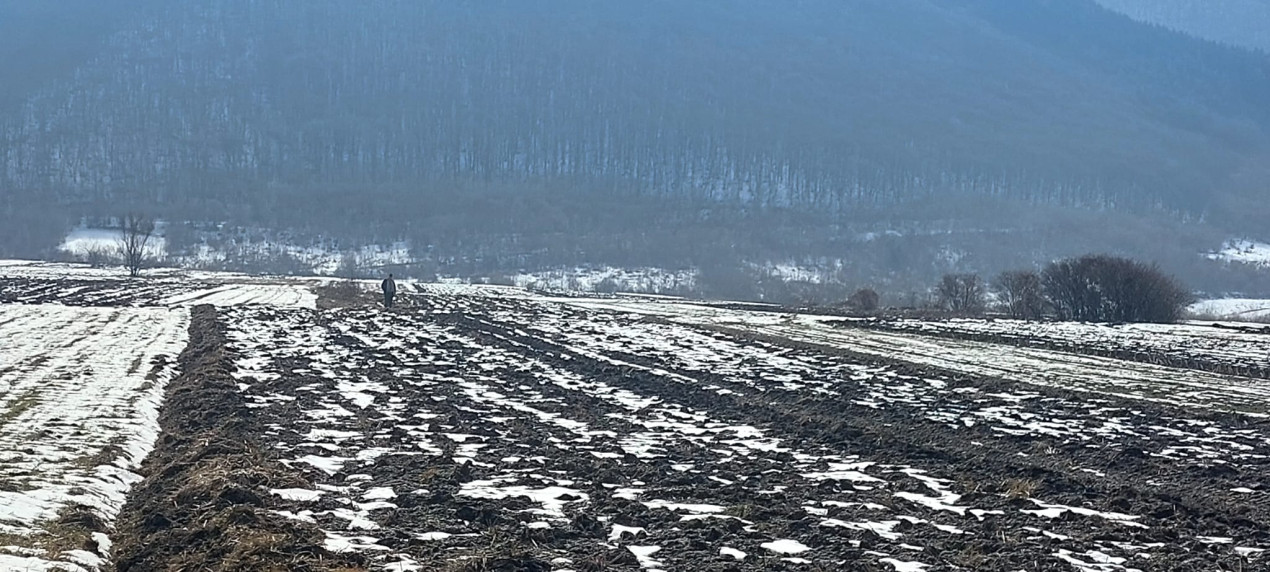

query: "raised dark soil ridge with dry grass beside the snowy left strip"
(114, 301), (362, 572)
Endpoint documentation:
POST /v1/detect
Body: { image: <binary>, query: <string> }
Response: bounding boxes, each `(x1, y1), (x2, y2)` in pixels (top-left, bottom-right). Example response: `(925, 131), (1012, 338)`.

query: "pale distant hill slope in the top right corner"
(1099, 0), (1270, 52)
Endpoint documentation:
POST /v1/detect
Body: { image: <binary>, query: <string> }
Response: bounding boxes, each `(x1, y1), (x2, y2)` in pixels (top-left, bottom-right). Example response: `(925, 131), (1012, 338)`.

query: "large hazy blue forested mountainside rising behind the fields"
(0, 0), (1270, 299)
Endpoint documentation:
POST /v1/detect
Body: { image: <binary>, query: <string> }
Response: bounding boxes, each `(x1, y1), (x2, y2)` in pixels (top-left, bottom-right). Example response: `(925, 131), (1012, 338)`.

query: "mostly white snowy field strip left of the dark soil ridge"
(0, 305), (189, 571)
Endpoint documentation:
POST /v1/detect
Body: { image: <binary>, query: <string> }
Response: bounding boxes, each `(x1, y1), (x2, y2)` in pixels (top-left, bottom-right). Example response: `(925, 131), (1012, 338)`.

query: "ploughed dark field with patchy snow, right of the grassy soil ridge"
(195, 292), (1270, 571)
